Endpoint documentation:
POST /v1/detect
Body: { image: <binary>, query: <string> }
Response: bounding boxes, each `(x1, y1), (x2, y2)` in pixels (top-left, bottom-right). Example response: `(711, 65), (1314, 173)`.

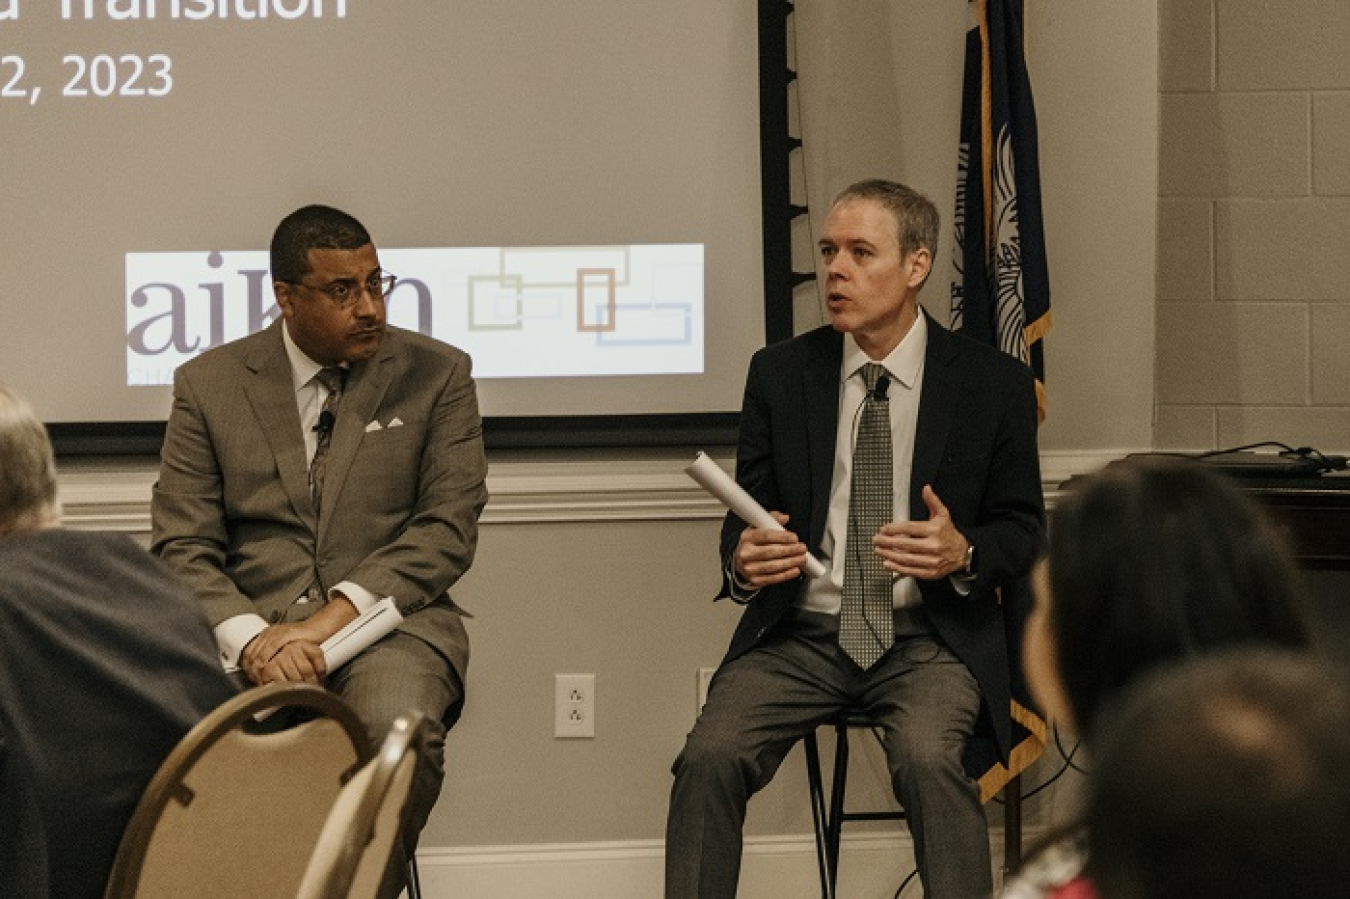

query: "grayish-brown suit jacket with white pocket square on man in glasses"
(151, 319), (487, 679)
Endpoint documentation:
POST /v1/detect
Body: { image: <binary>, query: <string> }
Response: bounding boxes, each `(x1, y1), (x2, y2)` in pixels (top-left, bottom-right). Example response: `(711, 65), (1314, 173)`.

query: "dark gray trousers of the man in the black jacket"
(666, 611), (994, 899)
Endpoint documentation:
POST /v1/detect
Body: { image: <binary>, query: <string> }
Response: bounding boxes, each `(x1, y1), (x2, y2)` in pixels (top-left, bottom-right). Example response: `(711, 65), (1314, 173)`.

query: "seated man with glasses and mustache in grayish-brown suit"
(151, 205), (487, 869)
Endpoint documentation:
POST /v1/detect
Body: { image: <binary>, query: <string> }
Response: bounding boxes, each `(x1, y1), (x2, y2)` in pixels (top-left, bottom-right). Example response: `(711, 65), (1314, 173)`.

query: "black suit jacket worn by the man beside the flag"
(721, 313), (1045, 757)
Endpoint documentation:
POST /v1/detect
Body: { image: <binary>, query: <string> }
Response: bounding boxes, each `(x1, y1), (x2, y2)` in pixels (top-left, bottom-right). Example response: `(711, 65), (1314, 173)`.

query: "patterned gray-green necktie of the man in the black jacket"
(840, 362), (895, 661)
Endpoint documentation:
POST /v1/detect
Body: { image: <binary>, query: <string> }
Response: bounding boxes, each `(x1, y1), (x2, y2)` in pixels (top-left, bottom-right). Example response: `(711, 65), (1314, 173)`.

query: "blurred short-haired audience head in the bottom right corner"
(1087, 651), (1350, 899)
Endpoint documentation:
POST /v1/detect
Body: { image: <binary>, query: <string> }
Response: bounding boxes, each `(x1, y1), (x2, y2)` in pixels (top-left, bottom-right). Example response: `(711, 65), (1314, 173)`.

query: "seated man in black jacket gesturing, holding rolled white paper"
(666, 181), (1044, 899)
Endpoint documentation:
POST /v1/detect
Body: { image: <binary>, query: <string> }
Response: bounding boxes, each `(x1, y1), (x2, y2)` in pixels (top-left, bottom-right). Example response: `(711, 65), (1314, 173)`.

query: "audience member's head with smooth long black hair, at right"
(1025, 456), (1310, 738)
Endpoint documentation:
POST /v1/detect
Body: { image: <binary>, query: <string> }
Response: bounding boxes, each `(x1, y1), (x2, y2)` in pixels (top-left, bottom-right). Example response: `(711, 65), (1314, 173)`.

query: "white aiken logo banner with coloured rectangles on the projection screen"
(126, 244), (703, 386)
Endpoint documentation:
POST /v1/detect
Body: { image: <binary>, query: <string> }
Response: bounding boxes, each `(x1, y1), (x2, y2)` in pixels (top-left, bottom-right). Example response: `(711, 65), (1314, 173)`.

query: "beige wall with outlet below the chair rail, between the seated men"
(423, 507), (729, 846)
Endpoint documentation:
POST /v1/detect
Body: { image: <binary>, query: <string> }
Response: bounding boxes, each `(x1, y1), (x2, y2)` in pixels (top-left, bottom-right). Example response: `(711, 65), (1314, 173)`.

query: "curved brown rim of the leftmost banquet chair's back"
(104, 683), (373, 899)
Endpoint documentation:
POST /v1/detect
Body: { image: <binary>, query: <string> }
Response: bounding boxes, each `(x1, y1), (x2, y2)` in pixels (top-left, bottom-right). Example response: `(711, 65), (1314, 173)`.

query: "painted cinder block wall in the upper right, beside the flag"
(1154, 0), (1350, 454)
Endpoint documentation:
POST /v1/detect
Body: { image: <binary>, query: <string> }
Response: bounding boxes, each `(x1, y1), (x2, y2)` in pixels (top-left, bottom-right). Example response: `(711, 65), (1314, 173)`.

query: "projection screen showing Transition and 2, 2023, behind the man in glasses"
(0, 0), (764, 443)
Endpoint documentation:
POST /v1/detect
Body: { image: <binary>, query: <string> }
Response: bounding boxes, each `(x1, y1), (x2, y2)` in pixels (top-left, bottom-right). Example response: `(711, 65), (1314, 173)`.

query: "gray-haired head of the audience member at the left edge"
(0, 385), (61, 537)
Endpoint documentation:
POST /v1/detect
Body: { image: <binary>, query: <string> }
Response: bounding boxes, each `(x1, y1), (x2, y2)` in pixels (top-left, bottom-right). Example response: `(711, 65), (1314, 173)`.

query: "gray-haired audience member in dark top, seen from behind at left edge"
(0, 386), (234, 899)
